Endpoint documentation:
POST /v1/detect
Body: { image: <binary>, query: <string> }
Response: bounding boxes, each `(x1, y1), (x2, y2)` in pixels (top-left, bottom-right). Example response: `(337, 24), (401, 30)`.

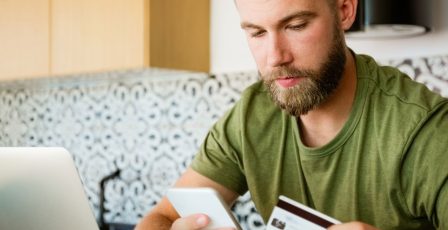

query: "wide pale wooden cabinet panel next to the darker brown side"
(51, 0), (149, 74)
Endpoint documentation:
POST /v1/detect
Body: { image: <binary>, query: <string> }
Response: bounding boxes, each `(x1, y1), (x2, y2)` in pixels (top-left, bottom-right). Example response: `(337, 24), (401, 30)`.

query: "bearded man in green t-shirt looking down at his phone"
(137, 0), (448, 229)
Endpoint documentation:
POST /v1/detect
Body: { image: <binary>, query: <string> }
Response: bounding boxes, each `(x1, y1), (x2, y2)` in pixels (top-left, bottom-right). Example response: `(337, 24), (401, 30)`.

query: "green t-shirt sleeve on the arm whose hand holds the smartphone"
(191, 103), (248, 195)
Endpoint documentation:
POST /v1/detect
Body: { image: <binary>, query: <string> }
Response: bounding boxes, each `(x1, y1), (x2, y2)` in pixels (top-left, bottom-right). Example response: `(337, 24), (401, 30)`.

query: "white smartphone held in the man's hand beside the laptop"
(166, 188), (241, 230)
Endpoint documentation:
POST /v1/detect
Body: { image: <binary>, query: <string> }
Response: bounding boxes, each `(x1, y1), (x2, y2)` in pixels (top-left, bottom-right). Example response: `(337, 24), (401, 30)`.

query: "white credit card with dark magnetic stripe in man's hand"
(266, 196), (341, 230)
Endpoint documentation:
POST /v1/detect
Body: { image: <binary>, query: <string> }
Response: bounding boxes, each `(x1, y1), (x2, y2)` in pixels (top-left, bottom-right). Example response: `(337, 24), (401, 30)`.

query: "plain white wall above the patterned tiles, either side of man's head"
(210, 0), (448, 73)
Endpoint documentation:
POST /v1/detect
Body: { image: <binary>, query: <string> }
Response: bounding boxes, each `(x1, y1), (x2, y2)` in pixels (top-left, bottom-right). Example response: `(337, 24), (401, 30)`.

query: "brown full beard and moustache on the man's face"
(261, 28), (346, 117)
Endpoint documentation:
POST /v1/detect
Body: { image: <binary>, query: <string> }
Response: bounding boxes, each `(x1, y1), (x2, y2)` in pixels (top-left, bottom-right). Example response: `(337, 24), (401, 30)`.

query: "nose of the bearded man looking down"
(267, 35), (293, 67)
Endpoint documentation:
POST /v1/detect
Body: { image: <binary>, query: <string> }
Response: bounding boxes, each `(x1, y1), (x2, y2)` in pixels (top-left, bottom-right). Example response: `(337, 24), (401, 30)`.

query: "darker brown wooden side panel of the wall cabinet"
(150, 0), (210, 72)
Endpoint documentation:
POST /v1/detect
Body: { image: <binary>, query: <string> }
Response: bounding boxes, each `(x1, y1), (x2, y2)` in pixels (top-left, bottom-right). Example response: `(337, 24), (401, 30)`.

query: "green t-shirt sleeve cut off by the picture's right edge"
(401, 103), (448, 229)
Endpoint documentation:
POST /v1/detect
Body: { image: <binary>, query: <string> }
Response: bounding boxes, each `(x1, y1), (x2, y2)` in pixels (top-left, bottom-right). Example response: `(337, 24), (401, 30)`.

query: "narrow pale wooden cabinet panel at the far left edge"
(0, 0), (49, 80)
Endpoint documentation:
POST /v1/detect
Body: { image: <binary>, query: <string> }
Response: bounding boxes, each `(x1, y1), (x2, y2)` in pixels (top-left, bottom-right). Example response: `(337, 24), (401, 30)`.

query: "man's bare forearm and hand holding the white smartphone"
(135, 168), (238, 230)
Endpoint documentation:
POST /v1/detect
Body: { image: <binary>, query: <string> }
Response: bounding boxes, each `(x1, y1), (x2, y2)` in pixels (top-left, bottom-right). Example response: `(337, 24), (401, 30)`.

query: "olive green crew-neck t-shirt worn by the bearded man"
(191, 55), (448, 229)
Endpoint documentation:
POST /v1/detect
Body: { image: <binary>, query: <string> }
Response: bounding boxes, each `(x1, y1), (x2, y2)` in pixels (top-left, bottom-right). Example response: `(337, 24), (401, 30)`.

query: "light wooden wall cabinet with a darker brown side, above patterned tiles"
(0, 0), (210, 80)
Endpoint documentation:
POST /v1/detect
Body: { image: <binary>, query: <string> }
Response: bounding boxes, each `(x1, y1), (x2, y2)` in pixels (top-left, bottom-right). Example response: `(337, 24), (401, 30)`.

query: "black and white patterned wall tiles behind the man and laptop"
(0, 56), (448, 229)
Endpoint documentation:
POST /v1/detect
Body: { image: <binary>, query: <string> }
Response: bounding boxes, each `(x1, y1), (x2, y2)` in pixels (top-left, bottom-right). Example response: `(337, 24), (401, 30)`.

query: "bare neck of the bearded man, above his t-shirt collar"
(298, 49), (357, 147)
